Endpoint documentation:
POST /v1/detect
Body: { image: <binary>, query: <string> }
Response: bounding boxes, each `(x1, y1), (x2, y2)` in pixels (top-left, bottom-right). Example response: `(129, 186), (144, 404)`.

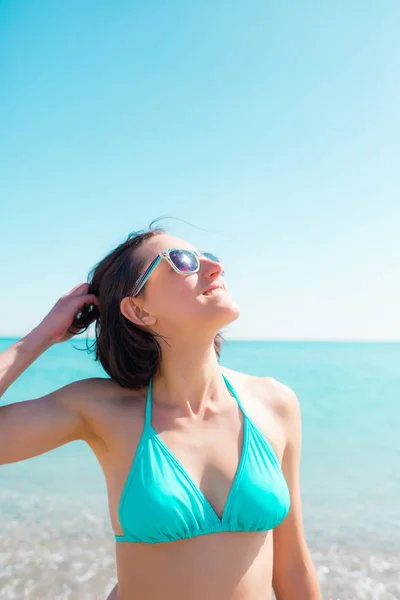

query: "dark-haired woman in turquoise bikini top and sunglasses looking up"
(0, 229), (320, 600)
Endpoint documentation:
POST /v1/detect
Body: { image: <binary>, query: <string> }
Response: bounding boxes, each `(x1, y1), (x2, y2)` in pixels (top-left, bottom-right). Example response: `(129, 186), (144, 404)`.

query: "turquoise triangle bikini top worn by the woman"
(115, 376), (290, 544)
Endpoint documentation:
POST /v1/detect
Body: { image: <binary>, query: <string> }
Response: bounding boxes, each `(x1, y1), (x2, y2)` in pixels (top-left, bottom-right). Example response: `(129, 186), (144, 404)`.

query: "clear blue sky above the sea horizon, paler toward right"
(0, 0), (400, 340)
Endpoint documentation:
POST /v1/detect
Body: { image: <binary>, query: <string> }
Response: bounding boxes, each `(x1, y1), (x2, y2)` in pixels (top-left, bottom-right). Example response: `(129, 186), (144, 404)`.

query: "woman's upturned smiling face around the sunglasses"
(126, 234), (240, 337)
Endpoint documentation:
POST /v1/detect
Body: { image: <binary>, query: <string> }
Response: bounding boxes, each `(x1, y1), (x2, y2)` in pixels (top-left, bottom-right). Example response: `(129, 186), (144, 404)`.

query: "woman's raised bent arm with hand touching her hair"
(0, 284), (97, 464)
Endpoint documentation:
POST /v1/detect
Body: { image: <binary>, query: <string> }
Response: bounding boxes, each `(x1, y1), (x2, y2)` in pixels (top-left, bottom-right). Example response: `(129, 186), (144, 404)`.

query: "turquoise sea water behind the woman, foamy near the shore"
(0, 339), (400, 600)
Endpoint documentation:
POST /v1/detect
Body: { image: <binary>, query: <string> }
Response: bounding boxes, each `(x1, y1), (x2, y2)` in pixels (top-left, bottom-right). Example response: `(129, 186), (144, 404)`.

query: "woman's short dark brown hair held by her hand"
(69, 226), (222, 389)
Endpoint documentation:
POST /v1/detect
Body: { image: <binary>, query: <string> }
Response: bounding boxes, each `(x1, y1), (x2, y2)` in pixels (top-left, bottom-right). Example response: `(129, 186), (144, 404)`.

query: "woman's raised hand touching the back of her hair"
(36, 283), (99, 344)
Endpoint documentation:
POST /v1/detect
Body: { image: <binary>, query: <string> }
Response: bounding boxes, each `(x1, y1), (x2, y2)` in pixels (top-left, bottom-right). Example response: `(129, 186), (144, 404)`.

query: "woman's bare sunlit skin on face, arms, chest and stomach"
(0, 238), (320, 600)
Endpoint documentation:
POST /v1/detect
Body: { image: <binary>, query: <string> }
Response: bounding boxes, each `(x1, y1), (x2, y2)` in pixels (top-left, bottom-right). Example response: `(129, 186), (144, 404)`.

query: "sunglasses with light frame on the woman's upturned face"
(131, 248), (221, 297)
